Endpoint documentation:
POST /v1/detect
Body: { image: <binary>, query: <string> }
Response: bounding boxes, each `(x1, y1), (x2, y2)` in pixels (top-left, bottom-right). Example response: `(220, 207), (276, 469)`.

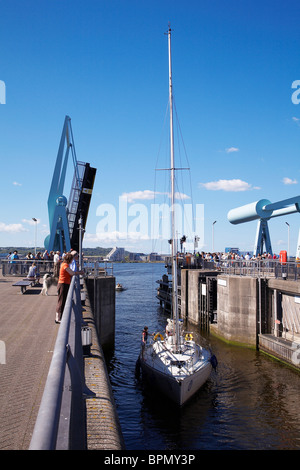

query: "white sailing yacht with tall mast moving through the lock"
(137, 26), (216, 406)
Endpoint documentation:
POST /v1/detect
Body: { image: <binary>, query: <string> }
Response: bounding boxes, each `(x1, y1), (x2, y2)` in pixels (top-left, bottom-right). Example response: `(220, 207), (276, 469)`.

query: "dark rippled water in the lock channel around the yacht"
(108, 264), (300, 451)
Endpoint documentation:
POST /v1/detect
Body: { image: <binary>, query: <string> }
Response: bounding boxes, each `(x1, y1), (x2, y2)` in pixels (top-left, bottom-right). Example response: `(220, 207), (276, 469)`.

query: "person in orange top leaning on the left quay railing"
(55, 253), (83, 323)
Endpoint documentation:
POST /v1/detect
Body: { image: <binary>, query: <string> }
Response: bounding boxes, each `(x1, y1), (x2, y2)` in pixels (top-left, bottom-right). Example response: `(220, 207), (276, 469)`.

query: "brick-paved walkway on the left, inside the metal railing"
(0, 277), (59, 450)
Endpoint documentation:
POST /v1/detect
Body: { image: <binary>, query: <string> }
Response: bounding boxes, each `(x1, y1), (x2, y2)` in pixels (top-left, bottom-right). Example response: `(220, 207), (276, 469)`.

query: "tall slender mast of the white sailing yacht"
(168, 25), (179, 349)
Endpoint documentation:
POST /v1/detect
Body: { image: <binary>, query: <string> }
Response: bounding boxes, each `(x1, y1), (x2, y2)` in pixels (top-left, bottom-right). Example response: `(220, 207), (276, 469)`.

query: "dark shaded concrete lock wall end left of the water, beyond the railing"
(86, 276), (116, 349)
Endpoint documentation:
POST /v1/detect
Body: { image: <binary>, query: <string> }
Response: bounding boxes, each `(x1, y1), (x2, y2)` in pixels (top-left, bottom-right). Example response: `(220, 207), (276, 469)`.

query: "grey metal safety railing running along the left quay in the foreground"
(29, 276), (93, 450)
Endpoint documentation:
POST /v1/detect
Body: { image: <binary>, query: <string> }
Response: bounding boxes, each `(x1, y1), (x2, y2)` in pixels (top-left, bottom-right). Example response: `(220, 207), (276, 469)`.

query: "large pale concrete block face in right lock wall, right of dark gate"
(215, 275), (258, 346)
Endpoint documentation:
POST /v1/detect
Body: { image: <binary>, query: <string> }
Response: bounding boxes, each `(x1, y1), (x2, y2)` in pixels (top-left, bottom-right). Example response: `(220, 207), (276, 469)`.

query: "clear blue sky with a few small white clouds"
(0, 0), (300, 255)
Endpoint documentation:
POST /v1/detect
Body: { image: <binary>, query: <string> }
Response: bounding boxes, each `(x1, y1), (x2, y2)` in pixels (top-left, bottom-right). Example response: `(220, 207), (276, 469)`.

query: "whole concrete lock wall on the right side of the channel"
(179, 269), (300, 360)
